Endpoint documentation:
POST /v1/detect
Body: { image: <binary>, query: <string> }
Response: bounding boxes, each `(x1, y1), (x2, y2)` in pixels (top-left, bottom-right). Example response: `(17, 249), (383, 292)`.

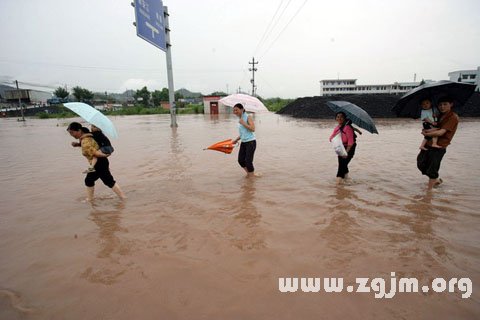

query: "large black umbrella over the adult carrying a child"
(392, 80), (475, 119)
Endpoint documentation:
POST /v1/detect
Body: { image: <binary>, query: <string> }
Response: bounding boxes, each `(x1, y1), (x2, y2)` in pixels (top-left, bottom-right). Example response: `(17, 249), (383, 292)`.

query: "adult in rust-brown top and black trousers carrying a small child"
(417, 96), (459, 190)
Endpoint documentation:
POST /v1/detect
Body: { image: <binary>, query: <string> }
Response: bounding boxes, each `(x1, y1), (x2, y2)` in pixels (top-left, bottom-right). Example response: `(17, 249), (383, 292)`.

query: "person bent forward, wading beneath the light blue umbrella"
(67, 122), (126, 202)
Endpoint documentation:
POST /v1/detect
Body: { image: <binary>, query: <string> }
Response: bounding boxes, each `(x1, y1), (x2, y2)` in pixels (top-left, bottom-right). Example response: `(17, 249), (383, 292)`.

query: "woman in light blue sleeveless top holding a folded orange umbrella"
(232, 103), (257, 177)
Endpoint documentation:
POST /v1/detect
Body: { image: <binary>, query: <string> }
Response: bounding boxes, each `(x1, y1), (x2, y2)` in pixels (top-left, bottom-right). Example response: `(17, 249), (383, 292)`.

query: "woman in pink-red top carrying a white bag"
(329, 111), (357, 184)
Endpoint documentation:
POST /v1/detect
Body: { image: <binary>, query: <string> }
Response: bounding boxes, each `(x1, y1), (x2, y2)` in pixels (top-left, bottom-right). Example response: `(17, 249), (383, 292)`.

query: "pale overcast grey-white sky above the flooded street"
(0, 0), (480, 98)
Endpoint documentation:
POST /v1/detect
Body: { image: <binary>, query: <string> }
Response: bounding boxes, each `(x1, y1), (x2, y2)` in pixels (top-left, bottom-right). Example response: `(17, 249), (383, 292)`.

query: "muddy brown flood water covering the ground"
(0, 114), (480, 319)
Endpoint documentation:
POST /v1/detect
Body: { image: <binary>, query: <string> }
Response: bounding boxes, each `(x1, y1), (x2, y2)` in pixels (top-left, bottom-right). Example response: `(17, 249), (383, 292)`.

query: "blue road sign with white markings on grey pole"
(135, 0), (167, 51)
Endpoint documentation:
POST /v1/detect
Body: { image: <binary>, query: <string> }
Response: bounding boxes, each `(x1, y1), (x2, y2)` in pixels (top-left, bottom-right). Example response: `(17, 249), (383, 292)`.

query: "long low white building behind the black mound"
(320, 79), (431, 96)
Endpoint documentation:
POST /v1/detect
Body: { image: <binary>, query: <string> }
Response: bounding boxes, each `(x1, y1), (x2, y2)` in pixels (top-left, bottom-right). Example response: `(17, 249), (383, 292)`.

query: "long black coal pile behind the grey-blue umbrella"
(277, 92), (480, 119)
